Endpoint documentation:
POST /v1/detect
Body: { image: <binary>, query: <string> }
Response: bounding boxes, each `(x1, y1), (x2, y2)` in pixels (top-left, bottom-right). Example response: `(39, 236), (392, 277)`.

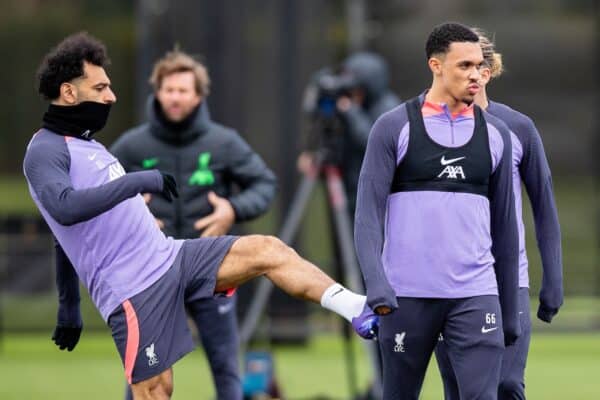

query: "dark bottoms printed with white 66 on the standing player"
(378, 295), (504, 400)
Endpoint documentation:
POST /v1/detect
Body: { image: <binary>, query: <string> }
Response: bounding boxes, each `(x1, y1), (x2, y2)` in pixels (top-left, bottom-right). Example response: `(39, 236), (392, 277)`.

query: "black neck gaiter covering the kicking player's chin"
(42, 101), (111, 140)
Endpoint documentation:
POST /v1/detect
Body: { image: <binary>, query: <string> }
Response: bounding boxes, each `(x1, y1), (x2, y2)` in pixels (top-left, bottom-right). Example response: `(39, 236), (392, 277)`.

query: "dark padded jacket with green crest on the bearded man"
(110, 98), (276, 238)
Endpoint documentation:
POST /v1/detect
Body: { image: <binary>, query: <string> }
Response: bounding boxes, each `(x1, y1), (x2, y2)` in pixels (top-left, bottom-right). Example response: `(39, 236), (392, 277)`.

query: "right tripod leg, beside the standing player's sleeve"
(325, 166), (383, 399)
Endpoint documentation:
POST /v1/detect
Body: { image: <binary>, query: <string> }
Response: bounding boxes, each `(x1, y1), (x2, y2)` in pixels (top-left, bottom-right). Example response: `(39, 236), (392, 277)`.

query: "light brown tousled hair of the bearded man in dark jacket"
(149, 48), (210, 97)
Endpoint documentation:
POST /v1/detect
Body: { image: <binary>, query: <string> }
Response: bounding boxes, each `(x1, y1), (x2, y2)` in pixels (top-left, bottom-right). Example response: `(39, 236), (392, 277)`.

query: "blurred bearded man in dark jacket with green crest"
(111, 51), (276, 400)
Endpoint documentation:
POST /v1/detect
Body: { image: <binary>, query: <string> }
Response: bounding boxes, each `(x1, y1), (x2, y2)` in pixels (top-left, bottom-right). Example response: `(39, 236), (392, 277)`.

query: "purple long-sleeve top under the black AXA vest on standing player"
(355, 97), (518, 324)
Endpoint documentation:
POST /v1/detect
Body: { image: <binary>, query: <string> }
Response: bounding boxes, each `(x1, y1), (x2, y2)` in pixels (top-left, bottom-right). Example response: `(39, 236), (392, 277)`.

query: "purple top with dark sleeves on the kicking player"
(23, 129), (182, 320)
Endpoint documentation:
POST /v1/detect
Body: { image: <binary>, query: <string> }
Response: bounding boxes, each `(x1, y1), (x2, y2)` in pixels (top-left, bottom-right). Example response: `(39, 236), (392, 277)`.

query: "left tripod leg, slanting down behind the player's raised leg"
(240, 170), (318, 347)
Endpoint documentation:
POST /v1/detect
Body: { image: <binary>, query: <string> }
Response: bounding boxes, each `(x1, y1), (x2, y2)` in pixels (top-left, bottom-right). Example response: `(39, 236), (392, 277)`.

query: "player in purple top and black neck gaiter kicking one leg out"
(23, 33), (376, 399)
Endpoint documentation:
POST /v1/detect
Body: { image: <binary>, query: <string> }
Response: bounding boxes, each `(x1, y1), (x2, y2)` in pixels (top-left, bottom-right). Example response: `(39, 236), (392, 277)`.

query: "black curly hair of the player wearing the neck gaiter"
(37, 32), (110, 100)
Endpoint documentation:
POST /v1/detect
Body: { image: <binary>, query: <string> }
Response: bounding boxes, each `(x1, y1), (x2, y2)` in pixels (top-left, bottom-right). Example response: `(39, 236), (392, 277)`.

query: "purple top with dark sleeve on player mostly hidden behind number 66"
(486, 101), (563, 319)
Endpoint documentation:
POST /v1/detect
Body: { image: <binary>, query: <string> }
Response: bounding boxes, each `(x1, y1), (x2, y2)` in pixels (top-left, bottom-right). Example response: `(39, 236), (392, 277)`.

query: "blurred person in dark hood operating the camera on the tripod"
(298, 52), (400, 212)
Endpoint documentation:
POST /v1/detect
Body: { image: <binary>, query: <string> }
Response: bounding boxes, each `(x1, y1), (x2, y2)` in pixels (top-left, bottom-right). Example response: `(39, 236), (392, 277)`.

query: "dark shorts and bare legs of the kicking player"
(126, 235), (378, 400)
